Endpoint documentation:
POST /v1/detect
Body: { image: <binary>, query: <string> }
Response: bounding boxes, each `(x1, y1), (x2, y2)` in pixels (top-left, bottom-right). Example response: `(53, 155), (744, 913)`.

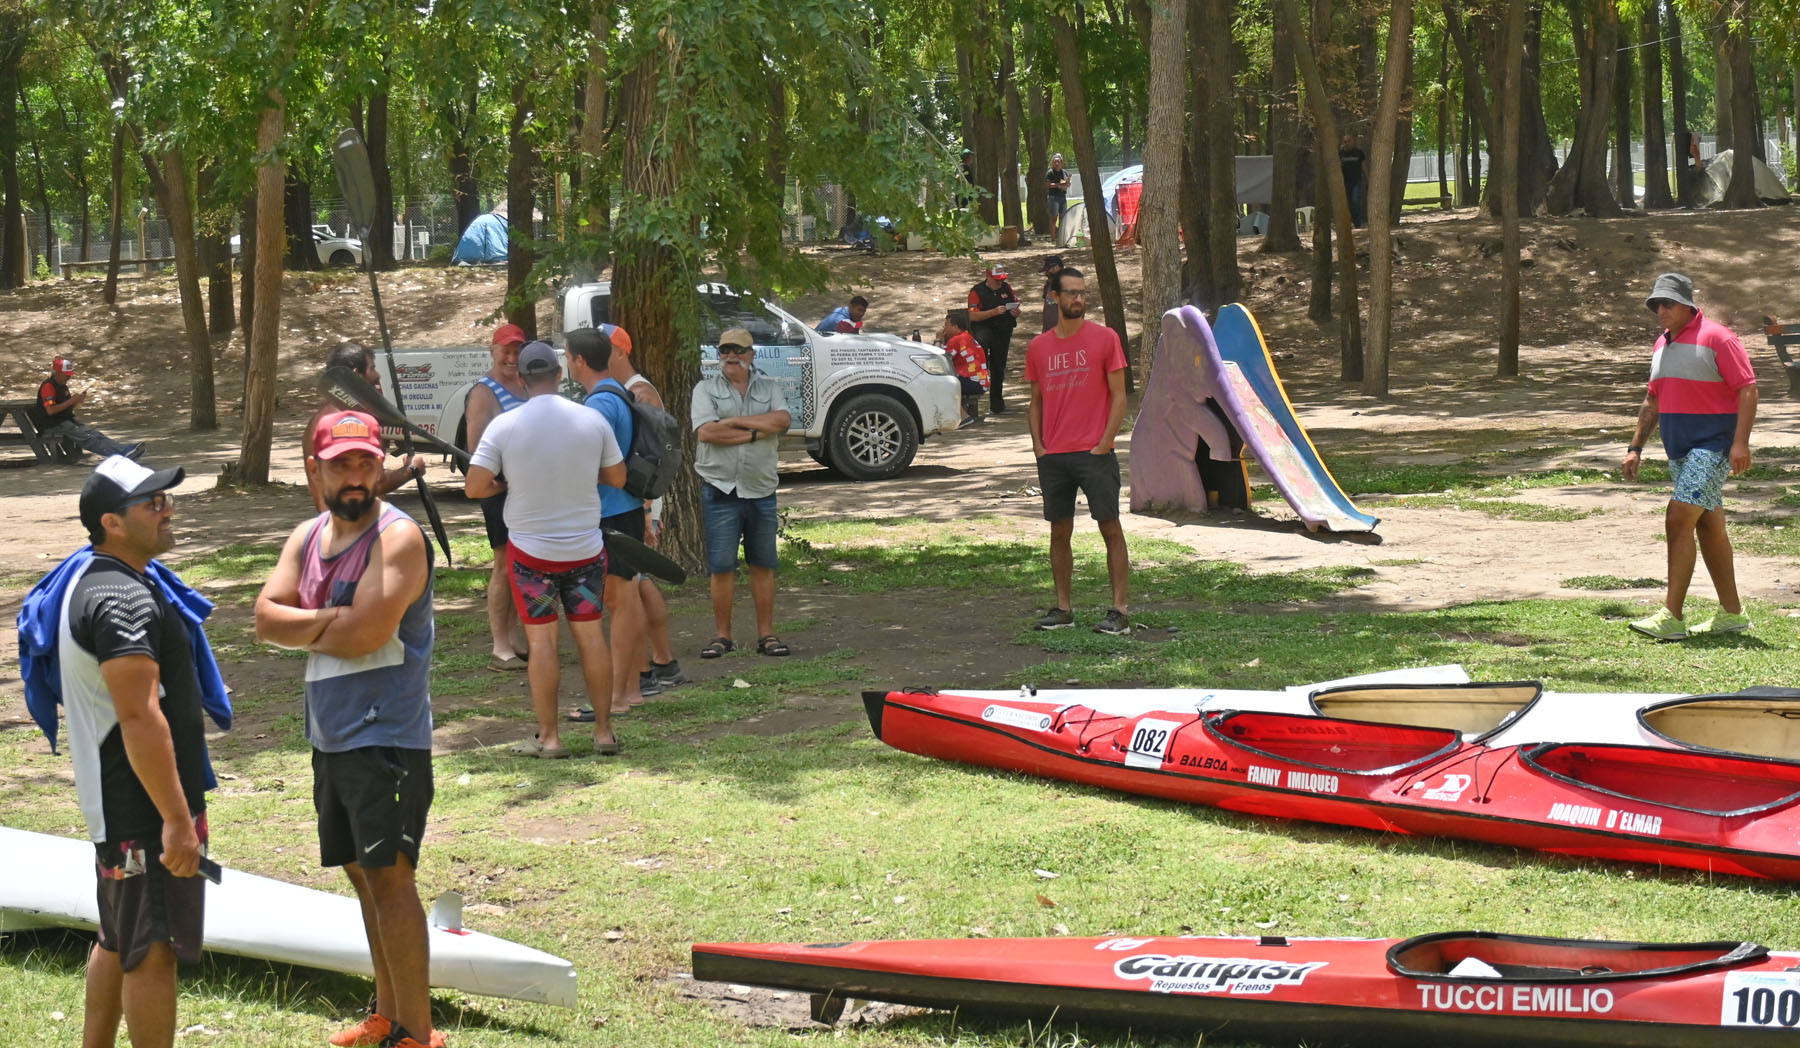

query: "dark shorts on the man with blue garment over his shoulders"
(94, 814), (207, 972)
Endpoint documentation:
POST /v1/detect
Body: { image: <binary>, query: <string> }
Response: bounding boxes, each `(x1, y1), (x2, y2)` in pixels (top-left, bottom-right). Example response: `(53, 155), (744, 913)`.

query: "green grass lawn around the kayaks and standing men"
(0, 507), (1800, 1048)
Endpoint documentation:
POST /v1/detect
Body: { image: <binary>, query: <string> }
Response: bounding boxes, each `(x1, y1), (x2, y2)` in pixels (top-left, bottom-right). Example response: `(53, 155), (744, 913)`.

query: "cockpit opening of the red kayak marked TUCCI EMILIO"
(1388, 931), (1769, 983)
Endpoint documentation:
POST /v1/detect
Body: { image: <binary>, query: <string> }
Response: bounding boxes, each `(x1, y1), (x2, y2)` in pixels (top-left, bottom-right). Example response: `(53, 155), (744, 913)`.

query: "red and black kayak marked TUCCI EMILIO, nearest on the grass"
(693, 931), (1800, 1048)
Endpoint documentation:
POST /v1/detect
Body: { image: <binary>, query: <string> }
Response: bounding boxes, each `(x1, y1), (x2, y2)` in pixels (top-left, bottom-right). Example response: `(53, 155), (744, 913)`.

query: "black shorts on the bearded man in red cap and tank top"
(313, 745), (434, 868)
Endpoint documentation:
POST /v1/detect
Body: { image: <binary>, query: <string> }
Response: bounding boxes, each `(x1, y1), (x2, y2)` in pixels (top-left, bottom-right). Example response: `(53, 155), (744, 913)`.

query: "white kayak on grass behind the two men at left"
(0, 827), (576, 1008)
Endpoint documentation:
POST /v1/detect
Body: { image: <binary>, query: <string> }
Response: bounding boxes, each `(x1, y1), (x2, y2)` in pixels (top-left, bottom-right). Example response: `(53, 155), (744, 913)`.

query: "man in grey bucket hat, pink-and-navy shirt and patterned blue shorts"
(1624, 274), (1757, 641)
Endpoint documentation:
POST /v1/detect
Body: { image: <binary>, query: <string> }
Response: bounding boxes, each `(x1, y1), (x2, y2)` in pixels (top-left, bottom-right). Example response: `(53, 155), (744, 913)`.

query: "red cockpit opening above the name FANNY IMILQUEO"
(1201, 709), (1462, 774)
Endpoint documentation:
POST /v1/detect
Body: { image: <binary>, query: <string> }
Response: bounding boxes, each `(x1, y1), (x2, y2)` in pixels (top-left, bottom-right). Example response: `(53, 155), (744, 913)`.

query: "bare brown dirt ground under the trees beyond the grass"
(10, 207), (1800, 747)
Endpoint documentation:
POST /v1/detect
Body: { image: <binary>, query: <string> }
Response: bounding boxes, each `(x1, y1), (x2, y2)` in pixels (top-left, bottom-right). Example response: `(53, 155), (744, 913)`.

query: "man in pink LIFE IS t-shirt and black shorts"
(1024, 268), (1130, 634)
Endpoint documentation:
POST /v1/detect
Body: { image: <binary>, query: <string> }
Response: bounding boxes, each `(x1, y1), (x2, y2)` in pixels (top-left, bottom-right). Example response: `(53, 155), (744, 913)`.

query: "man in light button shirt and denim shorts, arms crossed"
(691, 328), (792, 659)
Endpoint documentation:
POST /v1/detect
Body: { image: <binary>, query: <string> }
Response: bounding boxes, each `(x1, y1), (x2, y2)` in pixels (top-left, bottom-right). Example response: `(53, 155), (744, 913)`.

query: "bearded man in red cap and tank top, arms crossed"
(256, 411), (443, 1048)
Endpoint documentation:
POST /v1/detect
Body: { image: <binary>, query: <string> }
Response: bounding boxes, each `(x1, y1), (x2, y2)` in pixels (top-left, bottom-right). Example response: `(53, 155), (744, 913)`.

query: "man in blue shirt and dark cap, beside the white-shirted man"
(567, 328), (646, 720)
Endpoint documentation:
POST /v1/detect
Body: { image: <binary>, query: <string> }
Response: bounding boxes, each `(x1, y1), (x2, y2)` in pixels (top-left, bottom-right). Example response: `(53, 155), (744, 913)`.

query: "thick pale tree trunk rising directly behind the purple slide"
(1132, 2), (1195, 389)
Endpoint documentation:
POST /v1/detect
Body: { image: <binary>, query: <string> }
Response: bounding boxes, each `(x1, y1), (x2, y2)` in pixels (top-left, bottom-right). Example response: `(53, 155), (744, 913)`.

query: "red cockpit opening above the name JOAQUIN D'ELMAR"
(1519, 742), (1800, 818)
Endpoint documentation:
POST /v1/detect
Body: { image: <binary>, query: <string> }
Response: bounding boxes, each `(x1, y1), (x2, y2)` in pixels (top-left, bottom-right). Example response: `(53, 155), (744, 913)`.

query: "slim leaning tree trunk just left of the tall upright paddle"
(238, 90), (286, 484)
